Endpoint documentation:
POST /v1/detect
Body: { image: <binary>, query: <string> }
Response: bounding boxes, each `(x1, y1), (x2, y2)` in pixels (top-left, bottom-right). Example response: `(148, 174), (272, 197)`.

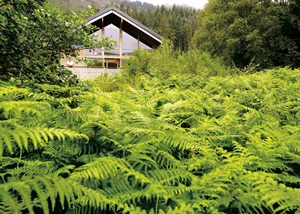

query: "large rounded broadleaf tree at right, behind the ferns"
(193, 0), (299, 68)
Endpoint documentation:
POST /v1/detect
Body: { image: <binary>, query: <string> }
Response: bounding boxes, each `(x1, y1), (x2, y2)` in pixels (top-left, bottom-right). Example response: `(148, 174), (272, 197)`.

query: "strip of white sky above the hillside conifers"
(142, 0), (208, 9)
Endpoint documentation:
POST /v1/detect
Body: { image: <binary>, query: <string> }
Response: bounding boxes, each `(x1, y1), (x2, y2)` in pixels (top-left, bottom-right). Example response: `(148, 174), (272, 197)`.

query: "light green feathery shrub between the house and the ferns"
(123, 40), (232, 79)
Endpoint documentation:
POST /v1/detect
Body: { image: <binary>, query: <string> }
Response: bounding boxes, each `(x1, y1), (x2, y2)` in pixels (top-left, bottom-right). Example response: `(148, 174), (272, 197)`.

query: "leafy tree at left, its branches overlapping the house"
(0, 0), (113, 84)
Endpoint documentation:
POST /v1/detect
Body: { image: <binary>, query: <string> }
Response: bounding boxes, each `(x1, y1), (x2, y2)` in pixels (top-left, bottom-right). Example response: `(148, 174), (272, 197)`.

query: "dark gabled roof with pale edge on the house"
(86, 6), (162, 48)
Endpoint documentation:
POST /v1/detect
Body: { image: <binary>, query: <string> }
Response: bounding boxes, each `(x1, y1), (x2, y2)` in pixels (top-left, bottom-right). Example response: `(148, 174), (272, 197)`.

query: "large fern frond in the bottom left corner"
(0, 174), (87, 213)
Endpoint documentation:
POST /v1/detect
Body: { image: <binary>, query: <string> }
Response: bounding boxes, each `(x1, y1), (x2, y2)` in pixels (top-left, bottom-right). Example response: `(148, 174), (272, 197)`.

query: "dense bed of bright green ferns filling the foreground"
(0, 66), (300, 214)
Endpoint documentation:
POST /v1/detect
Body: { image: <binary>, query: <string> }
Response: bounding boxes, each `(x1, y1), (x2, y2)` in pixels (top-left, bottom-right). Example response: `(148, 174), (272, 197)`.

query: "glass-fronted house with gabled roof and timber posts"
(61, 6), (162, 69)
